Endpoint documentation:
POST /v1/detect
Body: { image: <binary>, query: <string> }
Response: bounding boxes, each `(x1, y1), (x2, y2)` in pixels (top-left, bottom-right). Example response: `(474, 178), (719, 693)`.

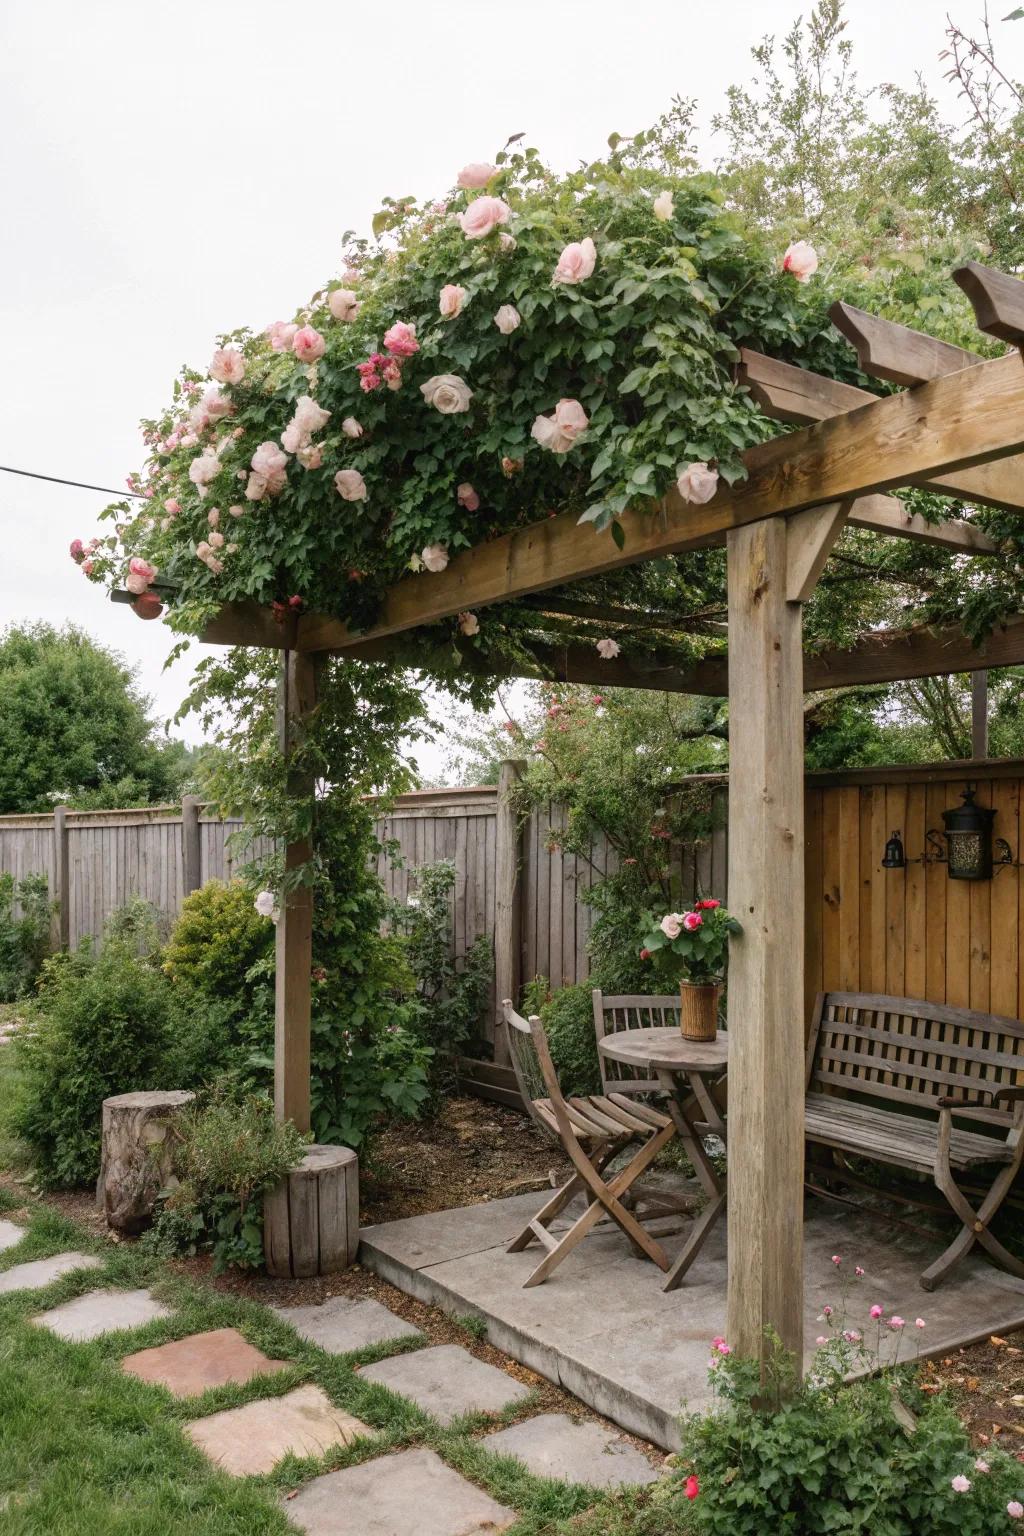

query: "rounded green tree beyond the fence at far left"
(0, 624), (192, 814)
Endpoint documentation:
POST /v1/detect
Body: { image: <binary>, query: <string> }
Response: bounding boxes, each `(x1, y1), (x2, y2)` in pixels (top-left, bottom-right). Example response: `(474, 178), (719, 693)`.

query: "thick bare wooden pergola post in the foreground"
(728, 518), (804, 1369)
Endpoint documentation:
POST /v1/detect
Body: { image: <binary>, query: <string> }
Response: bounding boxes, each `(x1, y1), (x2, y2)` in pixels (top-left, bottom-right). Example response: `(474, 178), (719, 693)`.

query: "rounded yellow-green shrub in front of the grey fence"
(164, 880), (273, 1008)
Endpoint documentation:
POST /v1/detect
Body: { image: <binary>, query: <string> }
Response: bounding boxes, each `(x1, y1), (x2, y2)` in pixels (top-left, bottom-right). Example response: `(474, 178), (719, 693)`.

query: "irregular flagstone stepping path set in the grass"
(0, 1221), (659, 1536)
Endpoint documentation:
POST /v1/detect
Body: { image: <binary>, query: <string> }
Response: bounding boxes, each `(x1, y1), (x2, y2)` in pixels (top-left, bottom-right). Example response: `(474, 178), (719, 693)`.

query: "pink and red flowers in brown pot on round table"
(640, 897), (743, 1040)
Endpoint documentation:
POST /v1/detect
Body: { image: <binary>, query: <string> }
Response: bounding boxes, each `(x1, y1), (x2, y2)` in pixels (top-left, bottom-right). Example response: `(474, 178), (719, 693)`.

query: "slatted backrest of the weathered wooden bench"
(808, 992), (1024, 1126)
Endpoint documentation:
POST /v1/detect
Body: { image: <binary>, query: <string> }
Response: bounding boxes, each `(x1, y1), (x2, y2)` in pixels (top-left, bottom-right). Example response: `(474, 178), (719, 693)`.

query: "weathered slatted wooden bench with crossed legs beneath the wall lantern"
(806, 992), (1024, 1290)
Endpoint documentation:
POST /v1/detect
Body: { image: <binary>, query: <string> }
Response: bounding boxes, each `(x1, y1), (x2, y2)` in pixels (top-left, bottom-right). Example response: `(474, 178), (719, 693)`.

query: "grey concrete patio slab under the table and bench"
(359, 1181), (1024, 1450)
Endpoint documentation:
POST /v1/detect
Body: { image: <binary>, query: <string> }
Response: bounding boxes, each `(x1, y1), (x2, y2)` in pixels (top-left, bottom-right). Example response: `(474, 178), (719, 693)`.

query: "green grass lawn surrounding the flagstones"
(0, 1173), (689, 1536)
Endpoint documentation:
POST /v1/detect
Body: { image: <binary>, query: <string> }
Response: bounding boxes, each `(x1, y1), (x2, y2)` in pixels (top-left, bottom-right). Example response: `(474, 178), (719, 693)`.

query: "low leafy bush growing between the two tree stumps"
(146, 1095), (309, 1273)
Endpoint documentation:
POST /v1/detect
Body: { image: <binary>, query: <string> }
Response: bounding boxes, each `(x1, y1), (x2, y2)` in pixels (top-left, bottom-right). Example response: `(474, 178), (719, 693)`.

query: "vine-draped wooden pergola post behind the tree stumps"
(273, 651), (316, 1130)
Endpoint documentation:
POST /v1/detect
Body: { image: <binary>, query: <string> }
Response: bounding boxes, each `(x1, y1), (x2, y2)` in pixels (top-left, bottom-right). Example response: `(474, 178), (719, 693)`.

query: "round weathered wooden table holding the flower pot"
(597, 1028), (729, 1290)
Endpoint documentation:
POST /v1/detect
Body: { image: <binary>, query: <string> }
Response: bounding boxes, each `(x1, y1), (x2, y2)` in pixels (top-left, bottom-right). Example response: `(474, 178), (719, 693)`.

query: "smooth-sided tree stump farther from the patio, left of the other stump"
(97, 1089), (195, 1233)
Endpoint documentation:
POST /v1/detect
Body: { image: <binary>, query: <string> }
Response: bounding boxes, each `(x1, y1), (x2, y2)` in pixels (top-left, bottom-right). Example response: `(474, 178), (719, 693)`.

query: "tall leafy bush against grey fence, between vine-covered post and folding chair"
(399, 859), (494, 1066)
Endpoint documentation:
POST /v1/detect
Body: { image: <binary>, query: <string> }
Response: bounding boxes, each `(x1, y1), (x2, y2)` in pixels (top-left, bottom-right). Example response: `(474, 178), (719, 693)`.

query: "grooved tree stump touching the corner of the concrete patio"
(263, 1146), (359, 1279)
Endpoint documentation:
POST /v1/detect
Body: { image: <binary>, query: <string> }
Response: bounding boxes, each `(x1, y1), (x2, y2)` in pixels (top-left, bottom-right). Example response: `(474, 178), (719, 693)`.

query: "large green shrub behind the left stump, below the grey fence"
(12, 940), (178, 1186)
